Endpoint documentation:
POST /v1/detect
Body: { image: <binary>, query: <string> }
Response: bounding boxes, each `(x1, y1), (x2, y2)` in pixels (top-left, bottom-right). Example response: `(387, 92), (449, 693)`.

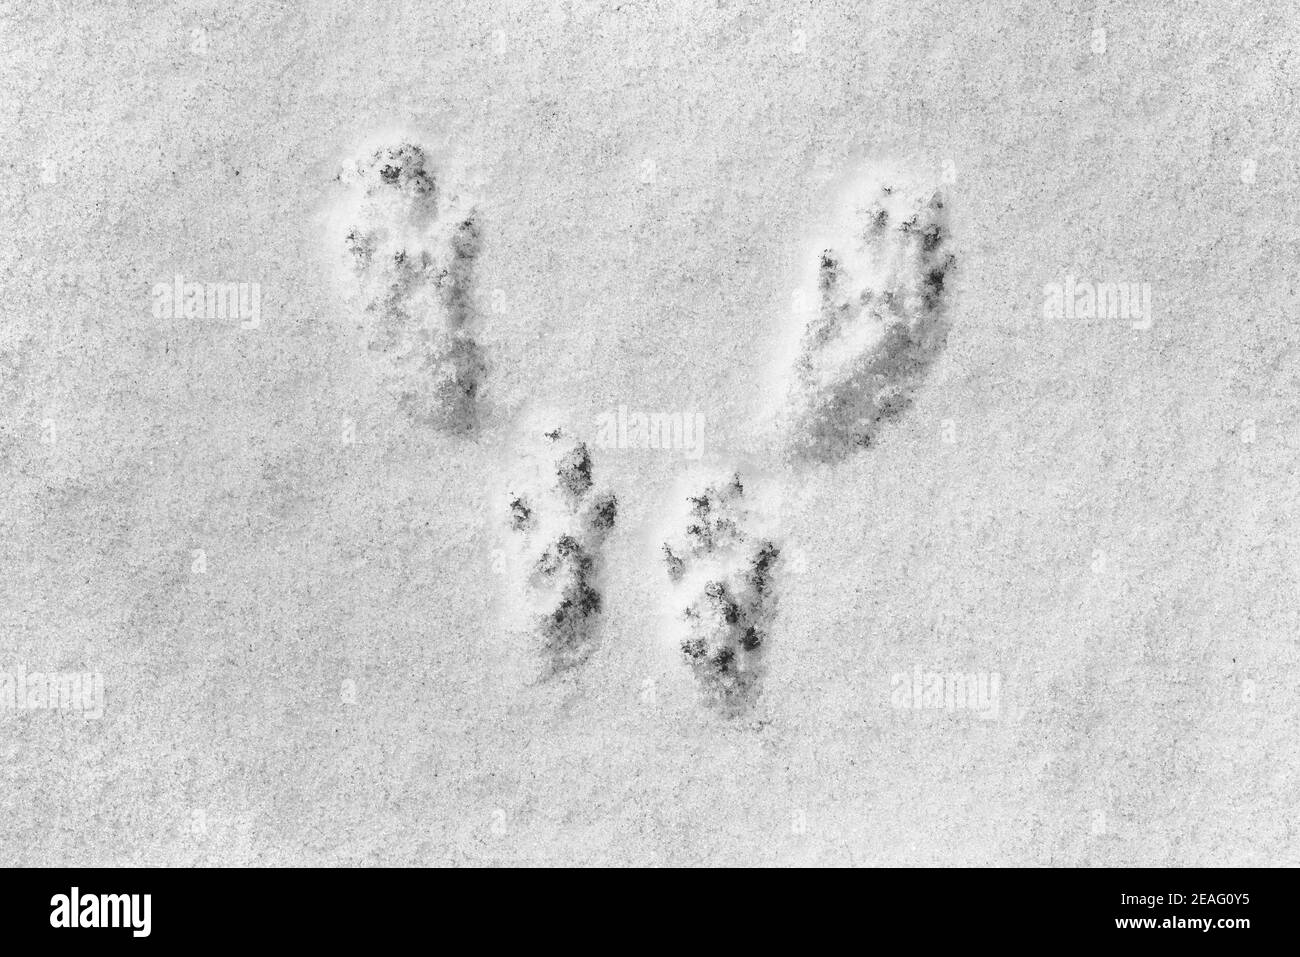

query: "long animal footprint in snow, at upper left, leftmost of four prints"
(338, 142), (486, 432)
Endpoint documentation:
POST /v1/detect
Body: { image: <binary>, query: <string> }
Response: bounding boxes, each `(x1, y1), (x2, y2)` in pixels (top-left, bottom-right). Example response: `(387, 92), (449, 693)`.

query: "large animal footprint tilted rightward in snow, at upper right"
(788, 169), (956, 460)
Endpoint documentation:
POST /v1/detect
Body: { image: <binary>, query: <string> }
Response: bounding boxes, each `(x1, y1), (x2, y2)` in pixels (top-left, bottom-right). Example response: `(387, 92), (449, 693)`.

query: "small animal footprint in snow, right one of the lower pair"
(663, 475), (780, 714)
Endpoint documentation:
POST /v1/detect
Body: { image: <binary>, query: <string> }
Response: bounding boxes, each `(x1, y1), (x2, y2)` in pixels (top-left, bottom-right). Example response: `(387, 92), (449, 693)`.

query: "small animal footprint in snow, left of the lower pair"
(510, 429), (618, 677)
